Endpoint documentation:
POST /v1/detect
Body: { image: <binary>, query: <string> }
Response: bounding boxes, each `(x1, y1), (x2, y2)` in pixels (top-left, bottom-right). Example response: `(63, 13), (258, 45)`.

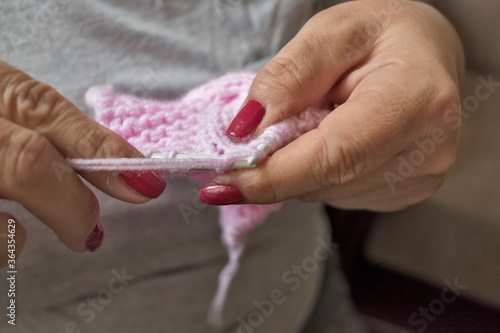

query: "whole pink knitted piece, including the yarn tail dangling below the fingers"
(81, 72), (330, 322)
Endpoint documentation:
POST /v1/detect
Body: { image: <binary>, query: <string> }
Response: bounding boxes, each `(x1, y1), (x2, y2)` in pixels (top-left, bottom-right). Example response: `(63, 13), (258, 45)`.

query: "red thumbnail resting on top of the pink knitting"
(226, 100), (266, 140)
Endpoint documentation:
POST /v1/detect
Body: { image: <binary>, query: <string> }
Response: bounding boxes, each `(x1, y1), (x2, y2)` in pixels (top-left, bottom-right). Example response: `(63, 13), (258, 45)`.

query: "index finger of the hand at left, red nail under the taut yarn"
(0, 62), (165, 203)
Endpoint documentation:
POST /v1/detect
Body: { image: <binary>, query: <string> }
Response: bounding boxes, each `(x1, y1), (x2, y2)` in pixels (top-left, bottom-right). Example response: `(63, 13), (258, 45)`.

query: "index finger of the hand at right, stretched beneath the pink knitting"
(202, 63), (454, 204)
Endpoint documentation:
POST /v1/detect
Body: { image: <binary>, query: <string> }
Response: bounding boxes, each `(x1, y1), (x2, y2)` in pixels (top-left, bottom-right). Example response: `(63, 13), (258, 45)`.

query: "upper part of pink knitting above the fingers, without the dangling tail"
(71, 73), (325, 177)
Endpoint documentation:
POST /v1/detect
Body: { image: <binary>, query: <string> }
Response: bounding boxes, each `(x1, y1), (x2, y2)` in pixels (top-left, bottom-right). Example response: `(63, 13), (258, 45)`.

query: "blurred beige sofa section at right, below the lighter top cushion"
(366, 71), (500, 306)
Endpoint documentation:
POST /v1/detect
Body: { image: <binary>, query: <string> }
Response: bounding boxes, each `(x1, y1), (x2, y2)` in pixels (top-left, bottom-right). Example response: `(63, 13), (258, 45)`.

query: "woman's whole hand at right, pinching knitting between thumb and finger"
(200, 0), (464, 211)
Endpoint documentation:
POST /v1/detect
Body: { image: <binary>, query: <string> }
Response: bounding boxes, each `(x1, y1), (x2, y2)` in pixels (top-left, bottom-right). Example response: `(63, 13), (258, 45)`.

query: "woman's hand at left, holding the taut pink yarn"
(0, 62), (165, 266)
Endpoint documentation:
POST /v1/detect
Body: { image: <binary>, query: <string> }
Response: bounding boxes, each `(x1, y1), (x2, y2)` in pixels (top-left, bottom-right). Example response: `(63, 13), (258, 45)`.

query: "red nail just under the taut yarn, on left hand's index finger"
(120, 171), (167, 199)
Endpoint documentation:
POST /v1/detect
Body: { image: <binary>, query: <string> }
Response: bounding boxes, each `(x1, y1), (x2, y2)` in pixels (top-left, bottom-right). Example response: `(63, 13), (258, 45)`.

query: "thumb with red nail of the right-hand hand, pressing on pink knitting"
(226, 3), (376, 141)
